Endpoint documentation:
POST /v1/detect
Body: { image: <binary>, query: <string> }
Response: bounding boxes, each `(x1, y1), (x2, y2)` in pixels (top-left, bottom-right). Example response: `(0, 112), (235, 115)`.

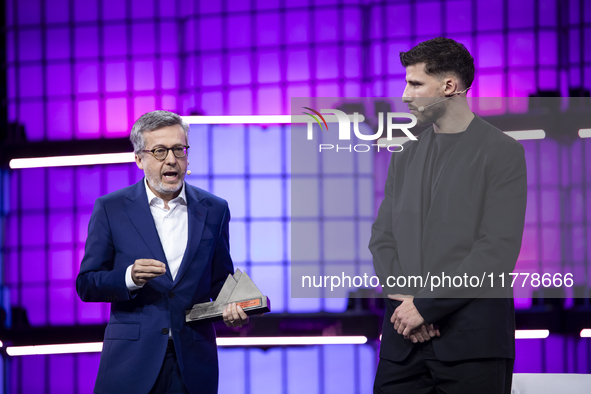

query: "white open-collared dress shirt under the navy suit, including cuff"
(125, 180), (189, 291)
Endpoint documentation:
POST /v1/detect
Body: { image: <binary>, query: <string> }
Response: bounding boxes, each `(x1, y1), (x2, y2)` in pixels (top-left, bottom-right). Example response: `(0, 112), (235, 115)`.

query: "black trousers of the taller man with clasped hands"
(374, 341), (514, 394)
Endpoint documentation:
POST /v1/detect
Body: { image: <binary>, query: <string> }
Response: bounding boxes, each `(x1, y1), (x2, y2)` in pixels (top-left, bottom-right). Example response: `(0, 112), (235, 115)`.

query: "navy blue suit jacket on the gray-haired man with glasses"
(76, 180), (233, 394)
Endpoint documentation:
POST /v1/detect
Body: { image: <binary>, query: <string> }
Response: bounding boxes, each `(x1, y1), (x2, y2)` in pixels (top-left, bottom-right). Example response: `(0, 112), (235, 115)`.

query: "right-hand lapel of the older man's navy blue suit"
(173, 183), (208, 287)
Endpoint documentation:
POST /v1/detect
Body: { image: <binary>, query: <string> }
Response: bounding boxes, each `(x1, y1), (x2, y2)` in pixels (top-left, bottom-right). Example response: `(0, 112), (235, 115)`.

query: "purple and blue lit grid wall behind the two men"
(2, 0), (591, 393)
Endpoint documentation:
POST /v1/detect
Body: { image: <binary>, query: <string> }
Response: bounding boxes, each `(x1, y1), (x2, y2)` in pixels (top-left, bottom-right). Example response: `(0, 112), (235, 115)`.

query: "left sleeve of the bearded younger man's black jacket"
(369, 155), (412, 294)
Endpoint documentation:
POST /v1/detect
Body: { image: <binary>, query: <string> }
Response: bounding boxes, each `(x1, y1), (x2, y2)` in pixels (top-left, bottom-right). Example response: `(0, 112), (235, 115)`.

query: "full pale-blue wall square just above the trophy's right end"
(250, 221), (284, 263)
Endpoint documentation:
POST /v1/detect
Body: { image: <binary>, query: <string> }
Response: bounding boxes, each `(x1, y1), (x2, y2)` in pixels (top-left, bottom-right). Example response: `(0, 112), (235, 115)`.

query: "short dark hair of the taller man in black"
(400, 37), (474, 89)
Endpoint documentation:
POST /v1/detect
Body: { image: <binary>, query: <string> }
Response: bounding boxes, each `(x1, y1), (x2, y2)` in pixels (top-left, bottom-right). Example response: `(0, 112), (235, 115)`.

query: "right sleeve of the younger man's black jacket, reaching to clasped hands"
(414, 143), (527, 323)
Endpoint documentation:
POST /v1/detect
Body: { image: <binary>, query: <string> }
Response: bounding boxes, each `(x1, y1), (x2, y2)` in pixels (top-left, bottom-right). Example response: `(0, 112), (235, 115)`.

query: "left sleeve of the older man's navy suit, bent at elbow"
(76, 198), (131, 302)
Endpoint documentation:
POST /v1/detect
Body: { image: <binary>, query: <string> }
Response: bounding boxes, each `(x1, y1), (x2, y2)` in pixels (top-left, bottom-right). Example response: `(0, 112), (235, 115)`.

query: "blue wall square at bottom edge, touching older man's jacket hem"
(218, 348), (246, 394)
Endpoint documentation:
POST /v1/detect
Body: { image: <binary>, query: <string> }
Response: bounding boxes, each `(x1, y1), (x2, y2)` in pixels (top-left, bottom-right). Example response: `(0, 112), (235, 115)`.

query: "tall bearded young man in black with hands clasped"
(369, 37), (527, 394)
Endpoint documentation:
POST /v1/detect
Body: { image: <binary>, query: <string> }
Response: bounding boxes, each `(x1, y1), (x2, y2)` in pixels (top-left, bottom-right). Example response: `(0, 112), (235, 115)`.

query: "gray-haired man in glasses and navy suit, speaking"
(76, 111), (248, 394)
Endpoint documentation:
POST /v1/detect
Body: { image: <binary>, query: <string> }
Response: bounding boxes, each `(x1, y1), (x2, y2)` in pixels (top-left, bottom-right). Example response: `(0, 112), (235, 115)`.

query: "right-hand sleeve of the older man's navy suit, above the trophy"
(210, 203), (234, 300)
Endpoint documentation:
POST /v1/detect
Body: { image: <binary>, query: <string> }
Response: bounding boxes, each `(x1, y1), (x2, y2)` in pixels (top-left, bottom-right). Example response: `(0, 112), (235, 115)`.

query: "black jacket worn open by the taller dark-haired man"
(369, 116), (527, 361)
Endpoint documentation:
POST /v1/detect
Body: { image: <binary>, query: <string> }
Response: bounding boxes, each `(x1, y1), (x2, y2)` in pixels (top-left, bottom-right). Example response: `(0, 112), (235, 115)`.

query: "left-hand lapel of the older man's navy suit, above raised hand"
(125, 179), (172, 282)
